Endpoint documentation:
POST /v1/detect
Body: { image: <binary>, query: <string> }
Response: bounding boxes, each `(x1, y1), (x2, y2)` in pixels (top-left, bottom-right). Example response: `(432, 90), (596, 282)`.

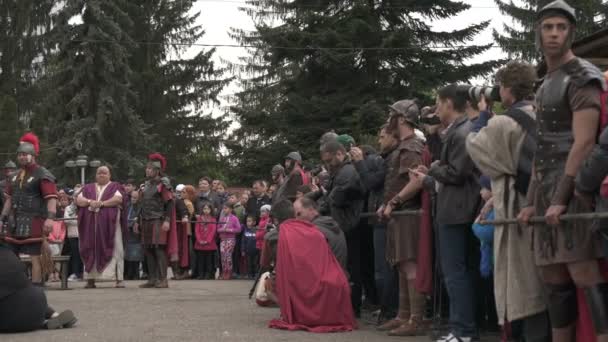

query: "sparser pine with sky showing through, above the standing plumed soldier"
(123, 0), (230, 181)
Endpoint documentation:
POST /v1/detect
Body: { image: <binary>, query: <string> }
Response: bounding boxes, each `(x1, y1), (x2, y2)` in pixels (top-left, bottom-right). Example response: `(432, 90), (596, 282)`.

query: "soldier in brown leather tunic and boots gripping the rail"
(379, 100), (430, 336)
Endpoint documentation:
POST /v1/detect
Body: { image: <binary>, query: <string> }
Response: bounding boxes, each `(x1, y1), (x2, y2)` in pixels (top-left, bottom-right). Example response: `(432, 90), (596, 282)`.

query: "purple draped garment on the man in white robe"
(78, 182), (128, 273)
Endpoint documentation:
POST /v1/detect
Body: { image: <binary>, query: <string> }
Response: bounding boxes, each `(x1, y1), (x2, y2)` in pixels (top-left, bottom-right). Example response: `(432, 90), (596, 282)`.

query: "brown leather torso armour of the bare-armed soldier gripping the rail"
(384, 137), (424, 209)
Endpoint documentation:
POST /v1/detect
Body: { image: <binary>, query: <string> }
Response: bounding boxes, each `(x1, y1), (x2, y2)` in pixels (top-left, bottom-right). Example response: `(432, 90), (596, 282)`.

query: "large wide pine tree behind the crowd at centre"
(228, 0), (504, 186)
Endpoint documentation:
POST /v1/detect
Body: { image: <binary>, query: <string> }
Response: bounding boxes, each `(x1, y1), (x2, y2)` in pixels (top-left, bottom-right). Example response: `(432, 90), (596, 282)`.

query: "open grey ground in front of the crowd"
(0, 280), (429, 342)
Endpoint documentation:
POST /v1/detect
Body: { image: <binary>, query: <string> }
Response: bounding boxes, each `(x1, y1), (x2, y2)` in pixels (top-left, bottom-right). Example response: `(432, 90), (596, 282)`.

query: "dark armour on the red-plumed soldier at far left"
(10, 167), (55, 238)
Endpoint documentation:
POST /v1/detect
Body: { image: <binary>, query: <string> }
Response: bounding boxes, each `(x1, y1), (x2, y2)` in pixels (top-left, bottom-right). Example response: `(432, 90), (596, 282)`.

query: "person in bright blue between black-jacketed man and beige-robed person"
(473, 176), (499, 332)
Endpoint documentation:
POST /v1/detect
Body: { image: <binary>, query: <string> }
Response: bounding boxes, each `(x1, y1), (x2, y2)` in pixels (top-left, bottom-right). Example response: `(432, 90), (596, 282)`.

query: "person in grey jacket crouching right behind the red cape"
(293, 196), (347, 271)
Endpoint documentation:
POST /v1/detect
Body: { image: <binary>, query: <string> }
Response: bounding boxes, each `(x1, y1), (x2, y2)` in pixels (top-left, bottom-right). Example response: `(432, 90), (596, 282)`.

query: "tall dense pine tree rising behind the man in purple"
(40, 0), (150, 178)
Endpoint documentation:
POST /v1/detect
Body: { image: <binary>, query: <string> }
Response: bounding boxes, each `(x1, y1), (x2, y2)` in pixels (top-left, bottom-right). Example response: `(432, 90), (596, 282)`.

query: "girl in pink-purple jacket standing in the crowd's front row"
(217, 203), (241, 280)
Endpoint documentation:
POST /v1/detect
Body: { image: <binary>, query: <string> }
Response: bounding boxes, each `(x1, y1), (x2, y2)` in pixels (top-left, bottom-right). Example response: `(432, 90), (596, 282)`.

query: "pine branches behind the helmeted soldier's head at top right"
(493, 0), (608, 62)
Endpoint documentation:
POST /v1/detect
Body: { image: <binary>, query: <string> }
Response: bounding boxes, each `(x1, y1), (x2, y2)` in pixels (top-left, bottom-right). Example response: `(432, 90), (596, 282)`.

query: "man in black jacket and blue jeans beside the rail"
(412, 84), (480, 342)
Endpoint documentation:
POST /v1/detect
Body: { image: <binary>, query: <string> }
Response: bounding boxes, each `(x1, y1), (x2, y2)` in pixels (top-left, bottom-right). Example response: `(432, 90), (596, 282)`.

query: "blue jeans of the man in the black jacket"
(439, 224), (478, 337)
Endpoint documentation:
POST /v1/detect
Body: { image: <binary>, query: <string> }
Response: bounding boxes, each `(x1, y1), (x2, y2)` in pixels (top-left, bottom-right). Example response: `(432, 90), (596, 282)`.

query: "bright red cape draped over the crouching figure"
(269, 220), (357, 333)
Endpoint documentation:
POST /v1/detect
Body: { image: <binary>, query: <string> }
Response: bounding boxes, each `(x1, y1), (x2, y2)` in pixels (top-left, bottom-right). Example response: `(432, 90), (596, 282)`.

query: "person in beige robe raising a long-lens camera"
(467, 61), (551, 341)
